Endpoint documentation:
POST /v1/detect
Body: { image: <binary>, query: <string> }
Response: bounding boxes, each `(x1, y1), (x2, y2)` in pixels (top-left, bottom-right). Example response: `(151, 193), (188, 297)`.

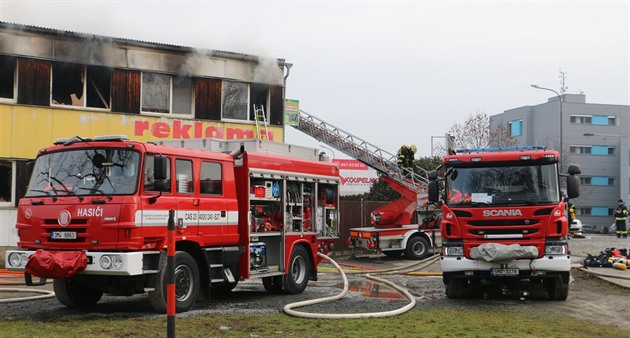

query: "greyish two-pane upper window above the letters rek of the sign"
(142, 72), (193, 115)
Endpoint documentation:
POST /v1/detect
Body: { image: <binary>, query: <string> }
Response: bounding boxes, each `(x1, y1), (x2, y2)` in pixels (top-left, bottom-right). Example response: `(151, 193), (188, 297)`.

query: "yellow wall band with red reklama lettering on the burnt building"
(0, 104), (284, 158)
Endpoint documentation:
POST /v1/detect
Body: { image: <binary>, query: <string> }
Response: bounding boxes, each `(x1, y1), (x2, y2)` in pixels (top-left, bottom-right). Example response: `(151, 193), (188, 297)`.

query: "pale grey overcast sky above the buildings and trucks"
(0, 0), (630, 157)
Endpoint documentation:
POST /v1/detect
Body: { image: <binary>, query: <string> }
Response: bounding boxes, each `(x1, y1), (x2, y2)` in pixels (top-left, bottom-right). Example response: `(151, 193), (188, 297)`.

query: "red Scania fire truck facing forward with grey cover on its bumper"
(429, 146), (580, 300)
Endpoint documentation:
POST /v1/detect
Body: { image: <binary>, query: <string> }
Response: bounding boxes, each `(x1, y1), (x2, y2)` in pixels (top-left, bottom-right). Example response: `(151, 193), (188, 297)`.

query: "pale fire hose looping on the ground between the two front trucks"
(284, 253), (439, 319)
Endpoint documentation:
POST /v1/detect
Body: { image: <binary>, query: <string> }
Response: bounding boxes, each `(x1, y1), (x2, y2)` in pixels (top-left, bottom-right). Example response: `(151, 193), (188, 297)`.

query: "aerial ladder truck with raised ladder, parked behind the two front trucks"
(293, 110), (440, 259)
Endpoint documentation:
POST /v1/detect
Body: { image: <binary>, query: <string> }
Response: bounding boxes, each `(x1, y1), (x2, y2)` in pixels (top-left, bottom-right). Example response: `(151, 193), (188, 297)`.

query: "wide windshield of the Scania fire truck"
(446, 164), (560, 206)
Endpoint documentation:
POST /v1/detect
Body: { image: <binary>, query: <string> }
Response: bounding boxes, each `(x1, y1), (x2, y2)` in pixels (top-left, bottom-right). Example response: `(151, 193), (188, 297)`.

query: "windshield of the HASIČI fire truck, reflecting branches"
(26, 148), (140, 198)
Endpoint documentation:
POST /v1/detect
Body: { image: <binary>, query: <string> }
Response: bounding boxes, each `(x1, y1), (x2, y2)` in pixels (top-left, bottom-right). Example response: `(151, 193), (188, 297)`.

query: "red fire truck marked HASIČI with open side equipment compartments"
(6, 136), (340, 312)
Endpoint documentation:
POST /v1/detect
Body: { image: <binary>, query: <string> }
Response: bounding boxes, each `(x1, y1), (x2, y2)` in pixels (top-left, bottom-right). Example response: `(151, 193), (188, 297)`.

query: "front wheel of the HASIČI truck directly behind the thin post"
(149, 251), (200, 313)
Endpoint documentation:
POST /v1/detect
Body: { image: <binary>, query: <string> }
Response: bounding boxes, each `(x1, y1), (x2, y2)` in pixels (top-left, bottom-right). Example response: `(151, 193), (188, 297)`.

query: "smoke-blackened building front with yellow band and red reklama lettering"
(0, 22), (290, 246)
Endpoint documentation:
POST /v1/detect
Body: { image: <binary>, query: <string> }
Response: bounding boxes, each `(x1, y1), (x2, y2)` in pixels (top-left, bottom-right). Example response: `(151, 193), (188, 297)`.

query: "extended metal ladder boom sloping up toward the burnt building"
(293, 110), (429, 193)
